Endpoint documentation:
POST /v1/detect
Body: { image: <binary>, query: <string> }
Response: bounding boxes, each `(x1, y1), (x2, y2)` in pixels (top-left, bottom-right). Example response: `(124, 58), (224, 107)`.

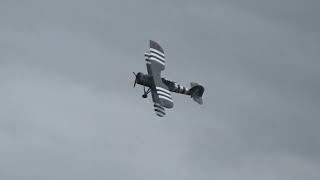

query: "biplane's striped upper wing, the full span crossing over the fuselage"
(145, 40), (173, 108)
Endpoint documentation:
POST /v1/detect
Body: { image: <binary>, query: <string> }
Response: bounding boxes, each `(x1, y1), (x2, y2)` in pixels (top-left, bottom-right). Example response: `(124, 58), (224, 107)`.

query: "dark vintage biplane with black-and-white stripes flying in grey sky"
(133, 40), (204, 117)
